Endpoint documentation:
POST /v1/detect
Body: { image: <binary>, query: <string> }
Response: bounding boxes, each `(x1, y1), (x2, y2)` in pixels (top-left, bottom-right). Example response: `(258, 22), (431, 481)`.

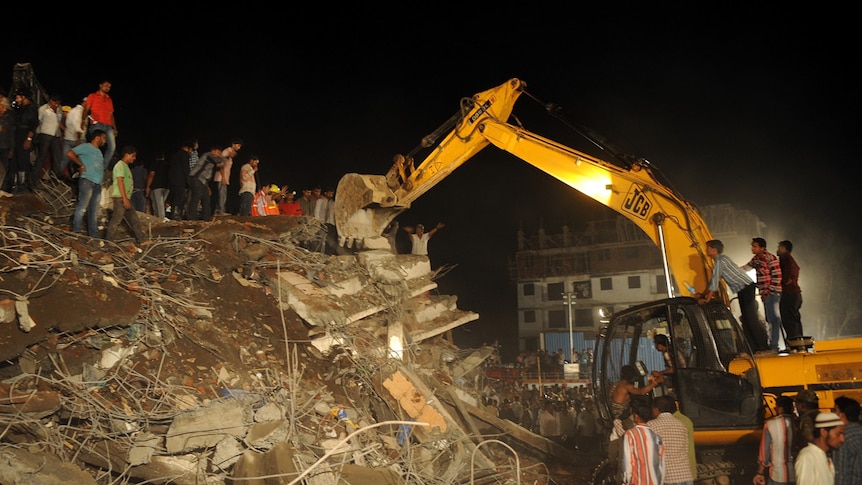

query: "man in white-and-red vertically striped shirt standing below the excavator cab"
(620, 399), (664, 485)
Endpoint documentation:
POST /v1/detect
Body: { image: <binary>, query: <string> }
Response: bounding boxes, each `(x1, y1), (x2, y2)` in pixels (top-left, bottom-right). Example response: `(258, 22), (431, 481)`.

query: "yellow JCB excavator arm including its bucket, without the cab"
(336, 79), (728, 303)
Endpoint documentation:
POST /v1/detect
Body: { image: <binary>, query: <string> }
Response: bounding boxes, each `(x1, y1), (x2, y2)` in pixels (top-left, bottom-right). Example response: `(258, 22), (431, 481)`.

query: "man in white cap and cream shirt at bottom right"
(795, 413), (844, 485)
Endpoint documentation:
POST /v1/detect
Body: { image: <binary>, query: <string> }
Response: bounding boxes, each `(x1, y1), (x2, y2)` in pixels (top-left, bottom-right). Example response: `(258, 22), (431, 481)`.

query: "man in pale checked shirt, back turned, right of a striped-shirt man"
(649, 395), (694, 485)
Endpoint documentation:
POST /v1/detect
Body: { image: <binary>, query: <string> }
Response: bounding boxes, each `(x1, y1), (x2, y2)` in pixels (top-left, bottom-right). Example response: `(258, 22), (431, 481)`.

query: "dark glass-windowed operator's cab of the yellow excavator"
(593, 297), (763, 432)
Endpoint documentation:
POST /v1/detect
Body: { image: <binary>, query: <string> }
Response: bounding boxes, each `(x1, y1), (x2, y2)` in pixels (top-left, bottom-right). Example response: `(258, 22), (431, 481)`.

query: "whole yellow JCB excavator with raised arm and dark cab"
(336, 79), (862, 484)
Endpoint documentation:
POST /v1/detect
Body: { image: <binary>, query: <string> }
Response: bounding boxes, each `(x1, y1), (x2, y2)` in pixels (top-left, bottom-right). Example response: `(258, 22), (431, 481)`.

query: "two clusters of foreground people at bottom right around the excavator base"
(608, 387), (862, 485)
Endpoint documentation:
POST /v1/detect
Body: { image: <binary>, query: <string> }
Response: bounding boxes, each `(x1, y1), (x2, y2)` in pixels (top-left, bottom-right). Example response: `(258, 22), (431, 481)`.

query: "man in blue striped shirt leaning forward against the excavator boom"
(698, 239), (769, 352)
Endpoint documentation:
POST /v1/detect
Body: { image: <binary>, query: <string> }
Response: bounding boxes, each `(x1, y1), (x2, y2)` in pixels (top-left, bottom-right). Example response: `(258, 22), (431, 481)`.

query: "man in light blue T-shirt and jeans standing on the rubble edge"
(66, 129), (108, 238)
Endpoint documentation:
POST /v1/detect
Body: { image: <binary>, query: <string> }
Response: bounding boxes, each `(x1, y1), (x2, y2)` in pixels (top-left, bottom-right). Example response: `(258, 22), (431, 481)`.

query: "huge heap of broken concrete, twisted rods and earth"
(0, 181), (595, 484)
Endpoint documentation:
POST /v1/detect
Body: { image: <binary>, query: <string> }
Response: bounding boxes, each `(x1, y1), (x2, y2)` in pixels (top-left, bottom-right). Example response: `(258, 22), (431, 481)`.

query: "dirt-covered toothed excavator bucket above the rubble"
(335, 173), (409, 247)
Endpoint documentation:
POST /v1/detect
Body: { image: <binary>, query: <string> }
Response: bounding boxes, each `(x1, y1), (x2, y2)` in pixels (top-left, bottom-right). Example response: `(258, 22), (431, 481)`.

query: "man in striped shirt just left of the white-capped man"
(752, 396), (796, 485)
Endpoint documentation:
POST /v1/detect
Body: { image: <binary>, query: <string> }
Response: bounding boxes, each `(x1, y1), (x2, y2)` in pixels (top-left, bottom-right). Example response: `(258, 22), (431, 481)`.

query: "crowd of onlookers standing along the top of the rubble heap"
(0, 80), (344, 243)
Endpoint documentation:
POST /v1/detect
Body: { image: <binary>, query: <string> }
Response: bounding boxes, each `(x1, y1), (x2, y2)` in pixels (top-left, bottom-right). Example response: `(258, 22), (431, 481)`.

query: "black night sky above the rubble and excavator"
(5, 10), (860, 348)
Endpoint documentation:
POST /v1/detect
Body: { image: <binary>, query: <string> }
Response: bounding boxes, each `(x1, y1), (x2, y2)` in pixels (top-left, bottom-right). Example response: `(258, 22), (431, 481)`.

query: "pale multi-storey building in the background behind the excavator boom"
(510, 204), (777, 359)
